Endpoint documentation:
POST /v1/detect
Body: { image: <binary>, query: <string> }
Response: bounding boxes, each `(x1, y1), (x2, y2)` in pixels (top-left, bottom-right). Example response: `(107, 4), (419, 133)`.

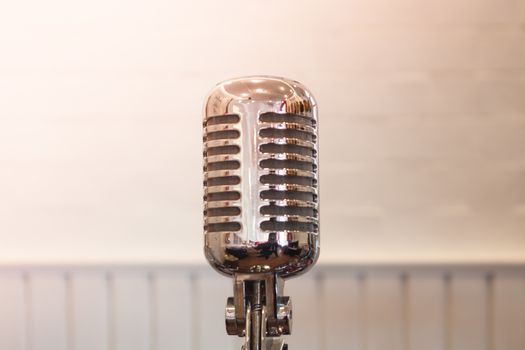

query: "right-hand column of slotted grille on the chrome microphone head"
(259, 112), (319, 233)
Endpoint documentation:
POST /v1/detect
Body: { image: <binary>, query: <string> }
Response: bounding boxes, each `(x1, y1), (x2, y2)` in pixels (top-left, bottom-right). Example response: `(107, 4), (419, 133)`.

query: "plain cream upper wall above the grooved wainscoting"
(0, 0), (525, 263)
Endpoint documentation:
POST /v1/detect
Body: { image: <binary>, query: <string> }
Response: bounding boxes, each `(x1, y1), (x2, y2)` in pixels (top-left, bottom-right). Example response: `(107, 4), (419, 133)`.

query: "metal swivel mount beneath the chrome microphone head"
(226, 273), (292, 350)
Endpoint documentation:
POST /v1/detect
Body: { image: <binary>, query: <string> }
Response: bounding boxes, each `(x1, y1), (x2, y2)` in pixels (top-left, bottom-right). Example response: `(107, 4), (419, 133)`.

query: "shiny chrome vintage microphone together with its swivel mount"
(203, 76), (319, 350)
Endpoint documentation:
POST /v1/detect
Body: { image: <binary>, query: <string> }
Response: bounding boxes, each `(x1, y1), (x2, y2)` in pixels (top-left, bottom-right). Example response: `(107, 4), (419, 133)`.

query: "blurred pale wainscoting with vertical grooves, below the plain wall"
(0, 265), (525, 350)
